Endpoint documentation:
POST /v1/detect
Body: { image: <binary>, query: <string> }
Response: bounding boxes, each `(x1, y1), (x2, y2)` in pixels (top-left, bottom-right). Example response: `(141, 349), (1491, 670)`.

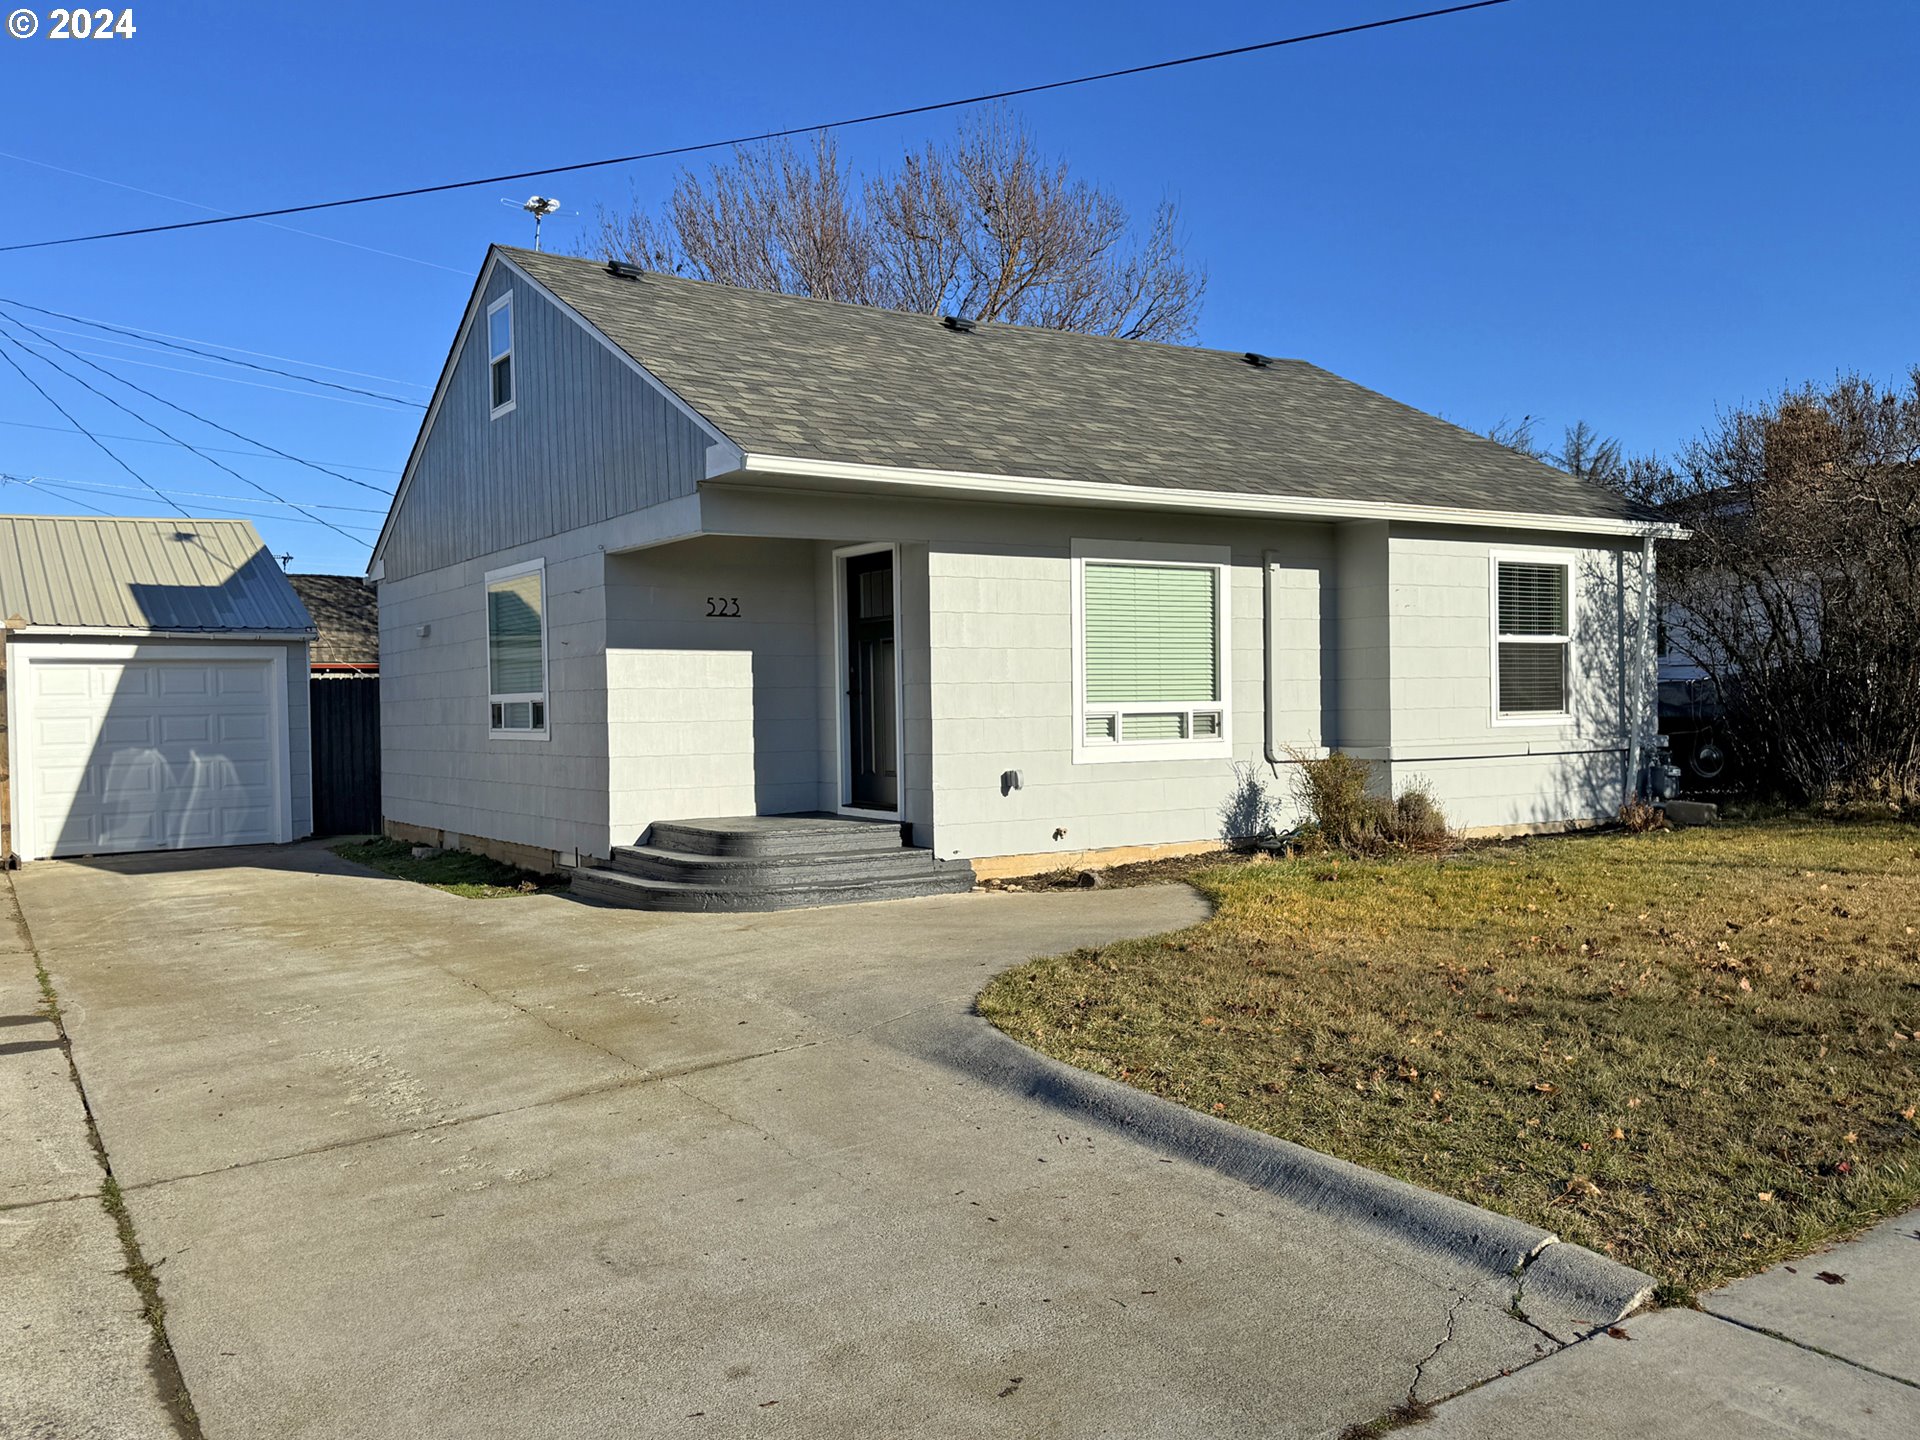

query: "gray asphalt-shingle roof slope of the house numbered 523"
(499, 248), (1649, 522)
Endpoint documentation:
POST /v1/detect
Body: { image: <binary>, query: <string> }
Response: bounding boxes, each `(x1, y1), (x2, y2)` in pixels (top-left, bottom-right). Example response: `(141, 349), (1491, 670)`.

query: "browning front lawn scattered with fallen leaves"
(979, 820), (1920, 1290)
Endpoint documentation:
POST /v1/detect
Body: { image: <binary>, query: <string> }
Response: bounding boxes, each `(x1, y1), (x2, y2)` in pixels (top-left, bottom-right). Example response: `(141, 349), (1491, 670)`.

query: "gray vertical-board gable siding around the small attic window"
(382, 263), (712, 580)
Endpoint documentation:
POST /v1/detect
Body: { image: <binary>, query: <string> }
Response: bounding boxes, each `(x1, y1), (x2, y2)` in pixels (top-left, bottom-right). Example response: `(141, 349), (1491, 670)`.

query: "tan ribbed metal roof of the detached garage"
(0, 515), (313, 637)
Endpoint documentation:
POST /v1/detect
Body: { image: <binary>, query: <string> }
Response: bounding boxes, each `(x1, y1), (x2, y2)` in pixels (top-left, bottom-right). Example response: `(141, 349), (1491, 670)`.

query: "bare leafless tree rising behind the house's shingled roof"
(588, 113), (1206, 340)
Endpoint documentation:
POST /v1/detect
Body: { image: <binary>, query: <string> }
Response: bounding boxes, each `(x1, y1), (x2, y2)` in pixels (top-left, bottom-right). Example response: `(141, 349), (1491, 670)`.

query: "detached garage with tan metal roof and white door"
(0, 516), (313, 875)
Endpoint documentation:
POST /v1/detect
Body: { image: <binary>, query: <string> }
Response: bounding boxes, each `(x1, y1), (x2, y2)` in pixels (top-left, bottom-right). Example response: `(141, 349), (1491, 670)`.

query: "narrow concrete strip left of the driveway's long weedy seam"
(0, 877), (177, 1440)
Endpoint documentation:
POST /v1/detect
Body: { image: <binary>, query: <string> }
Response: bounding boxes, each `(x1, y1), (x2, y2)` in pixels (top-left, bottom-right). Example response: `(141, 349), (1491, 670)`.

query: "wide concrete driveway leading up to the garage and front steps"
(17, 847), (1549, 1440)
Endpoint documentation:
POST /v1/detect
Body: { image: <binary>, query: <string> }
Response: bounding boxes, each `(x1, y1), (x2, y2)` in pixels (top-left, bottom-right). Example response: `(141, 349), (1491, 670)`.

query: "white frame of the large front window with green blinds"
(1071, 540), (1233, 764)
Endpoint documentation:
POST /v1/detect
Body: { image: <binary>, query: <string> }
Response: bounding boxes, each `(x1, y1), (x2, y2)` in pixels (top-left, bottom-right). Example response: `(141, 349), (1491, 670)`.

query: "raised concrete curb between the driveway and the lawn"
(889, 1014), (1653, 1331)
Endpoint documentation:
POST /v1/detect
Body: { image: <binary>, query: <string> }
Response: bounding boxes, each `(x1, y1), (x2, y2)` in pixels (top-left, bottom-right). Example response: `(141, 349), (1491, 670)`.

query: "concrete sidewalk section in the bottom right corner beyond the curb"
(1419, 1210), (1920, 1440)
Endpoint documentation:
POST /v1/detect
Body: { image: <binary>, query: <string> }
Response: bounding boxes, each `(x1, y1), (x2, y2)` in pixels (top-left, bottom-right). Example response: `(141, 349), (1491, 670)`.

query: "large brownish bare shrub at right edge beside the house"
(1624, 367), (1920, 804)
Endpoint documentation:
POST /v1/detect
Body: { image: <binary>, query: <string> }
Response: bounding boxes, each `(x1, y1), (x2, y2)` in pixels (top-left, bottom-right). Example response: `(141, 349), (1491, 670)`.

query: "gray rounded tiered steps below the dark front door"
(572, 814), (973, 912)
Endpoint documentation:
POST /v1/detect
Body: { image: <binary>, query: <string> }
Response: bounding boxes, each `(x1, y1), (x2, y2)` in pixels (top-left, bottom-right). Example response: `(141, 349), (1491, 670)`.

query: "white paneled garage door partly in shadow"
(15, 657), (284, 858)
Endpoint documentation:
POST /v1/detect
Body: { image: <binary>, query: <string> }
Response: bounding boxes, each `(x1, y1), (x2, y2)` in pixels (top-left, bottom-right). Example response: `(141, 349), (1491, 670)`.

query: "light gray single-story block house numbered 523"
(371, 248), (1670, 902)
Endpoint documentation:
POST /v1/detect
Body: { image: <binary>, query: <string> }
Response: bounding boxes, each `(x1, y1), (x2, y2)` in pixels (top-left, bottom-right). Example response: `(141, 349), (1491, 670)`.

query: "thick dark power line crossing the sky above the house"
(0, 0), (1511, 253)
